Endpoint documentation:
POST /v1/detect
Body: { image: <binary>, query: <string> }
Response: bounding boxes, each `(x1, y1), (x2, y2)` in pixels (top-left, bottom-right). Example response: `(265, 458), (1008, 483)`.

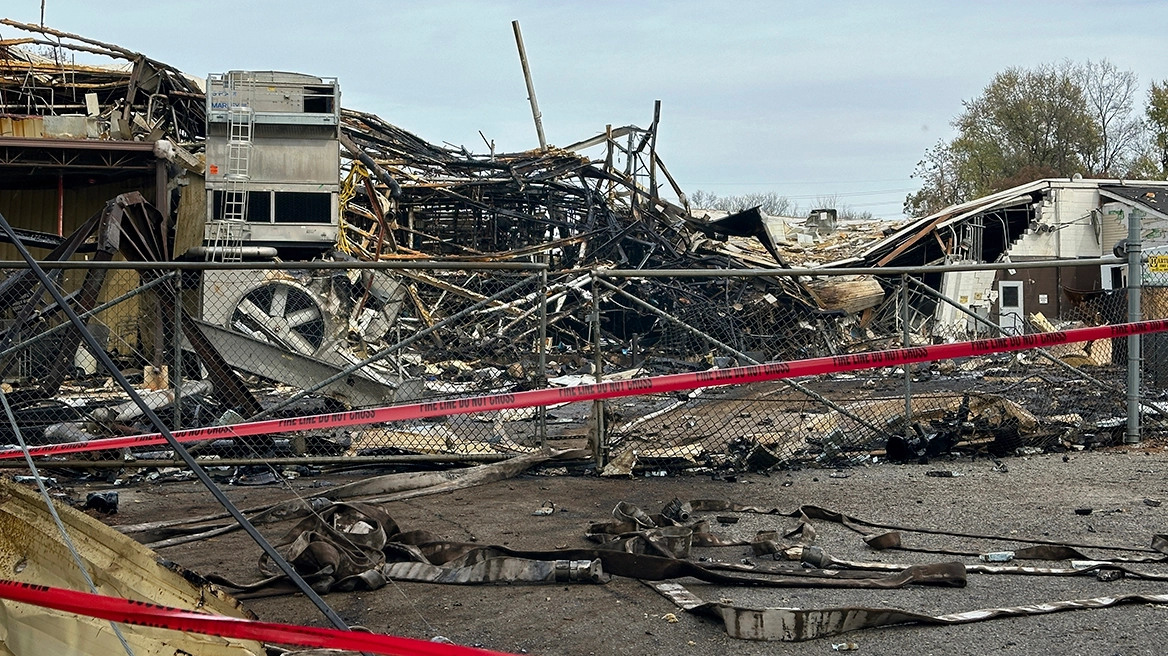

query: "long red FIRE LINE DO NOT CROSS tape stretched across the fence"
(9, 320), (1168, 459)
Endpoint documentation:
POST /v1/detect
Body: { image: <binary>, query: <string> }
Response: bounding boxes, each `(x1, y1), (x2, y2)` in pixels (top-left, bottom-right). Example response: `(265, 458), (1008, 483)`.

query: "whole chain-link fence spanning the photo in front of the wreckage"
(0, 255), (1163, 473)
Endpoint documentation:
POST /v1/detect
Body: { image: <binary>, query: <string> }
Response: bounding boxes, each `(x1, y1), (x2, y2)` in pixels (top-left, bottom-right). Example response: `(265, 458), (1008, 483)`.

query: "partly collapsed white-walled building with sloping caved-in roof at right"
(825, 179), (1168, 336)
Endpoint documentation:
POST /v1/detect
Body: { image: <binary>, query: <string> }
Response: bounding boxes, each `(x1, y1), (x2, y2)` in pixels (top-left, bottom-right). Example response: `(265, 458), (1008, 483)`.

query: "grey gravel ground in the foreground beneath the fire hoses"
(91, 445), (1168, 655)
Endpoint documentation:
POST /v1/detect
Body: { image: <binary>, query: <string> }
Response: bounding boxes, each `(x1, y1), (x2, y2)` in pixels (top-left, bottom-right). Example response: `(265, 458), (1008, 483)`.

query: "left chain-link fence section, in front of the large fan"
(0, 264), (553, 461)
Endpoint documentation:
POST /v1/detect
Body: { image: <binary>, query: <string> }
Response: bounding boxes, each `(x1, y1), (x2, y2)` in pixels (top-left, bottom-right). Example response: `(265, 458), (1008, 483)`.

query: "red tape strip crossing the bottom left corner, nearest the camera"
(0, 579), (508, 656)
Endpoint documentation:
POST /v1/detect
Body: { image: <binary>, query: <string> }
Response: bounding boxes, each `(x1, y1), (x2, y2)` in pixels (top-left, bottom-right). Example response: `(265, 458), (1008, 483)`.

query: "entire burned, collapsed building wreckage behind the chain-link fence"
(0, 21), (1159, 468)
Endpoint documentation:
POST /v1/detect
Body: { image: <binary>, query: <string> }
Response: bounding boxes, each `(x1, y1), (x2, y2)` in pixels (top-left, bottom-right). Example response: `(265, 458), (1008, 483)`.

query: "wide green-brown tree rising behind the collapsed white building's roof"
(904, 60), (1149, 216)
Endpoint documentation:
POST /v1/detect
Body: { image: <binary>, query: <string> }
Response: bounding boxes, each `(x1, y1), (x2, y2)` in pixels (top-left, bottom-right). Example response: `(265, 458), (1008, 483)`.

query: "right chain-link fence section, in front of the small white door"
(600, 263), (1168, 473)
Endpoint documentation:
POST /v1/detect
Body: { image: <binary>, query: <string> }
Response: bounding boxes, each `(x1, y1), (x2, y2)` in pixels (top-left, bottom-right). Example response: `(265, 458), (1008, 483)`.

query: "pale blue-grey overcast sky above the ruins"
(0, 0), (1168, 218)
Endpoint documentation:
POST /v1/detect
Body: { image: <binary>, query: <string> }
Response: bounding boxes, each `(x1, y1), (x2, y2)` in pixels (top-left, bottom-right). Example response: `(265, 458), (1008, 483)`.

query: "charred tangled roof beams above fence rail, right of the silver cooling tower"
(343, 111), (690, 268)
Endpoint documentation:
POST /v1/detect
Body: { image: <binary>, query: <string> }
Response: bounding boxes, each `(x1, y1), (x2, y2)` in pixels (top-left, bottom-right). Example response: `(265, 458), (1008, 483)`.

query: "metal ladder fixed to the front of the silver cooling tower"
(207, 71), (256, 261)
